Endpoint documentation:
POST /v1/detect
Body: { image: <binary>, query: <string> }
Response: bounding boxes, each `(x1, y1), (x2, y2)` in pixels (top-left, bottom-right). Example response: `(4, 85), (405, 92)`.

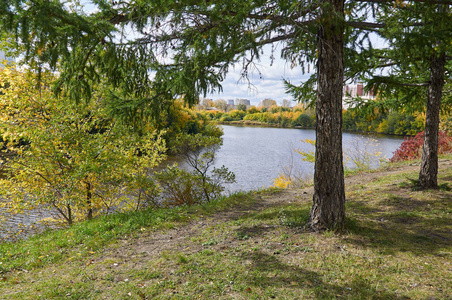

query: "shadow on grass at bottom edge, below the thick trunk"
(241, 252), (407, 299)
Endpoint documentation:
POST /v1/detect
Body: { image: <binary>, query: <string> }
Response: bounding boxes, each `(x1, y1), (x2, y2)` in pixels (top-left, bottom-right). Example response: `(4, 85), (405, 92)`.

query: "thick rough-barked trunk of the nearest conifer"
(308, 0), (345, 231)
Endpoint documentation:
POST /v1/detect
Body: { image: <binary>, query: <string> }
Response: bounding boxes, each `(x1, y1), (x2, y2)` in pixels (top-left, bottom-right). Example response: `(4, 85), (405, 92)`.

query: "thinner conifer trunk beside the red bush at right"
(419, 54), (446, 188)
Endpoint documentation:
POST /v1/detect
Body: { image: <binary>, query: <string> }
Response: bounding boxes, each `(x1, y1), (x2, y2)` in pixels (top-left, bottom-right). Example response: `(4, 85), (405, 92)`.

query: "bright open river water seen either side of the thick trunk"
(208, 126), (403, 191)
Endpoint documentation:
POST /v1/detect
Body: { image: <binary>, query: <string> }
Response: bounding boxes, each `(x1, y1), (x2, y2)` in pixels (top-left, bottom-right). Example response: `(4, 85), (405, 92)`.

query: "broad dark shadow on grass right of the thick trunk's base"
(344, 197), (452, 255)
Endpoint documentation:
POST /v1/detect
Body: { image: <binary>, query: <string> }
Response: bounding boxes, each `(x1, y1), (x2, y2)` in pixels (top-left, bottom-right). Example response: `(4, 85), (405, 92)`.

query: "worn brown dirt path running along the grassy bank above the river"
(95, 160), (452, 268)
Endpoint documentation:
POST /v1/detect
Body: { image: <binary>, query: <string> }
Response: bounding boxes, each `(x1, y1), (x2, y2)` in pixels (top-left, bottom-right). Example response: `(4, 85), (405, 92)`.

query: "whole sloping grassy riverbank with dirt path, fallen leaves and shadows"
(0, 155), (452, 299)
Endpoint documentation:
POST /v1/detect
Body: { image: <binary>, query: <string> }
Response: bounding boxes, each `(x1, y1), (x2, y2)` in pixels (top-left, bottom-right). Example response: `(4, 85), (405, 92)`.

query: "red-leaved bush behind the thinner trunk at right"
(390, 131), (452, 162)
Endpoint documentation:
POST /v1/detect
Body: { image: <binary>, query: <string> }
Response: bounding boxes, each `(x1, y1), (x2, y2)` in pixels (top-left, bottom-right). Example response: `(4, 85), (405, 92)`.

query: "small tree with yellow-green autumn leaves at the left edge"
(0, 68), (165, 224)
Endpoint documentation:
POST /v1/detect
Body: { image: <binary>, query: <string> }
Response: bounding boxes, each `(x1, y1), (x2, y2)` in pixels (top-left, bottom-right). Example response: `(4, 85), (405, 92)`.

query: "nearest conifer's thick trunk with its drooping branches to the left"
(0, 0), (345, 230)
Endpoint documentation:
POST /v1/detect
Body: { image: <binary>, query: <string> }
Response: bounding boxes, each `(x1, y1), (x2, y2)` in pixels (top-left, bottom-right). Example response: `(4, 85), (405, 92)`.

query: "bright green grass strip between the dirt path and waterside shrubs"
(0, 193), (254, 276)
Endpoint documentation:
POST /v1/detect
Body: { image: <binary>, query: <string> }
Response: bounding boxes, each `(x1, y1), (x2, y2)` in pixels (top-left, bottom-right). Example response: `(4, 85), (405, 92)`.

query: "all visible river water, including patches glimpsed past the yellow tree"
(0, 126), (402, 241)
